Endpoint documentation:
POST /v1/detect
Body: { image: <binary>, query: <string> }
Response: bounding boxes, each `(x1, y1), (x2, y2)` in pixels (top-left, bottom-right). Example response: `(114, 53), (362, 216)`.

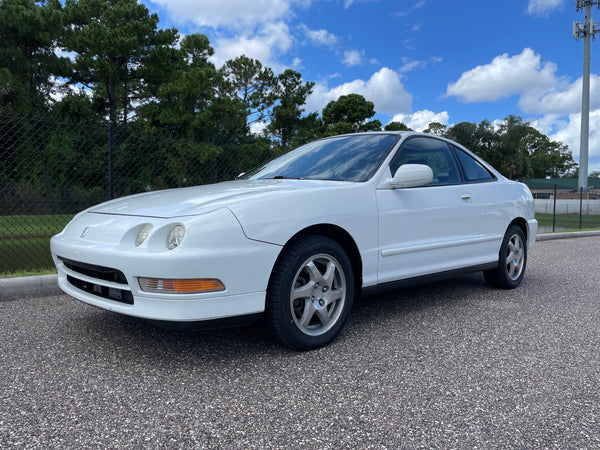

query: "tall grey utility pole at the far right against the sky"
(573, 0), (600, 189)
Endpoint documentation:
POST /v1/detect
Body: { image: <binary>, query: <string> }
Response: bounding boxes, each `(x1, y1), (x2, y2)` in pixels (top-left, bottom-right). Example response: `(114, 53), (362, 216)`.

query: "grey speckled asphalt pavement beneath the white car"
(0, 237), (600, 448)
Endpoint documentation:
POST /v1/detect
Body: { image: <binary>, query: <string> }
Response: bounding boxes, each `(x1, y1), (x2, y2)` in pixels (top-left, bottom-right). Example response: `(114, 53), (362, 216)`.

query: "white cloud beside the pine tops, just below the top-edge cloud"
(213, 22), (293, 72)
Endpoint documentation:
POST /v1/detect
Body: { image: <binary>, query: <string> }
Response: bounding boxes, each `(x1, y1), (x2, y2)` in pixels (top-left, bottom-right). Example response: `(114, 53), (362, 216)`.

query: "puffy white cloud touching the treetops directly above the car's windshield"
(305, 67), (412, 114)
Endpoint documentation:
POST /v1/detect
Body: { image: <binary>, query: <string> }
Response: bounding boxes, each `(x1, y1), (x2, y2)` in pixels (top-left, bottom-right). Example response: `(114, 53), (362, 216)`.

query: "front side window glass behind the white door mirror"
(390, 137), (462, 186)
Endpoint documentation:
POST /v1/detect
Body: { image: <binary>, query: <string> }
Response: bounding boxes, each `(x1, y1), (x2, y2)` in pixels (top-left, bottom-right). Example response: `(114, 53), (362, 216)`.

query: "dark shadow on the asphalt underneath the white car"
(67, 274), (493, 364)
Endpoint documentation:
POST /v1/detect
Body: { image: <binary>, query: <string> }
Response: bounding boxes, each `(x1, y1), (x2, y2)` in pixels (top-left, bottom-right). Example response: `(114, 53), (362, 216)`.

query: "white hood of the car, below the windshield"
(87, 179), (354, 218)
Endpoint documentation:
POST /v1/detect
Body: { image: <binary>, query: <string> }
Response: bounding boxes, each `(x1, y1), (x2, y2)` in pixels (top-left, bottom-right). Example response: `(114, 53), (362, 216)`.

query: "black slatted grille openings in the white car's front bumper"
(61, 258), (133, 305)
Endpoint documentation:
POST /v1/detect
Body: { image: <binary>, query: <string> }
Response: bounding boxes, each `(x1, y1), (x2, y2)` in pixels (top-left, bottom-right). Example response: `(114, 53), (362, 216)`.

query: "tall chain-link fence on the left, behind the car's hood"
(0, 113), (272, 275)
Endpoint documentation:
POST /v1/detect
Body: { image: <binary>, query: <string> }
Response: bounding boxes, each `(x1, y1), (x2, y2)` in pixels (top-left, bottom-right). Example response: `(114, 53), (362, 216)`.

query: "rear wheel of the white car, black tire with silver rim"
(483, 225), (527, 289)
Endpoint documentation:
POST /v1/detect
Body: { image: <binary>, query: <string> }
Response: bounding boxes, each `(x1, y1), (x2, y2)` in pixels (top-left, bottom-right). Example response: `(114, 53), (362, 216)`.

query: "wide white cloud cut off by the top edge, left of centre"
(150, 0), (296, 29)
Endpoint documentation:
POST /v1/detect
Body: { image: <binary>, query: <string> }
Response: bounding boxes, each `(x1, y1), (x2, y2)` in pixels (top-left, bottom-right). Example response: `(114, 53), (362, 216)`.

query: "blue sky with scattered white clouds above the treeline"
(142, 0), (600, 172)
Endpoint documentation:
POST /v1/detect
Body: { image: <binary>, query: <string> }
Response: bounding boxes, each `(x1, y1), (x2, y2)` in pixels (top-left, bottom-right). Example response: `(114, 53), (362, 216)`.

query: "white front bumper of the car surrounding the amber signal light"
(50, 210), (281, 322)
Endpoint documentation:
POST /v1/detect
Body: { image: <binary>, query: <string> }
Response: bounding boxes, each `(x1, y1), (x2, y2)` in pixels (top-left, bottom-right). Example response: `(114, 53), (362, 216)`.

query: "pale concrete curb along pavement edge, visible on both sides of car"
(0, 231), (600, 301)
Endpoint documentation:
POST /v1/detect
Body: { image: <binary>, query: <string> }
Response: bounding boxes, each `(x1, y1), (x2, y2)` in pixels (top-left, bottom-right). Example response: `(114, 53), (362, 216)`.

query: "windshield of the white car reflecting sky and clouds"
(240, 134), (398, 181)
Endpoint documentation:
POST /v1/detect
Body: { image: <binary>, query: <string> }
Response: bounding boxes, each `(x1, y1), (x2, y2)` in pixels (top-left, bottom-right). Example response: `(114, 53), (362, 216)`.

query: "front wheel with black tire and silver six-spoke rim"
(265, 235), (354, 350)
